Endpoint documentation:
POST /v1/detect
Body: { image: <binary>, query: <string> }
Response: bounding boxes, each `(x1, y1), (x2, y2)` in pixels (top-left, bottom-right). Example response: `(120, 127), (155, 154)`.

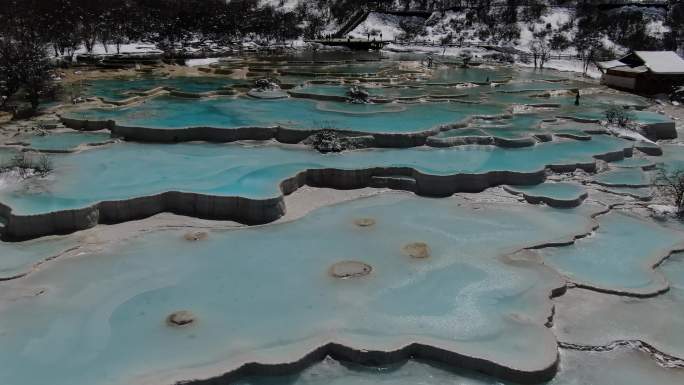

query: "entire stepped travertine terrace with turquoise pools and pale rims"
(0, 52), (684, 385)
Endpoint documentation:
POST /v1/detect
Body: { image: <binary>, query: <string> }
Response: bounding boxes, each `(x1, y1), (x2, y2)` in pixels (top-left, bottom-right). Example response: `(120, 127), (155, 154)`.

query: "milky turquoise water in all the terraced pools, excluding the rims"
(5, 60), (684, 385)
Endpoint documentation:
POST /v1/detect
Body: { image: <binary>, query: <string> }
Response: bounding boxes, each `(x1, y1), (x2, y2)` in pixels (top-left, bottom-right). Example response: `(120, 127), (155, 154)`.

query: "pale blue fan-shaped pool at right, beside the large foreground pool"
(539, 213), (684, 293)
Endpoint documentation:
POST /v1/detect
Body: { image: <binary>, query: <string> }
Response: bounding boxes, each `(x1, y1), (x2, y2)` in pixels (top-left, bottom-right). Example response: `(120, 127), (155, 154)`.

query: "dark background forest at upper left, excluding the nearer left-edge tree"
(0, 0), (307, 55)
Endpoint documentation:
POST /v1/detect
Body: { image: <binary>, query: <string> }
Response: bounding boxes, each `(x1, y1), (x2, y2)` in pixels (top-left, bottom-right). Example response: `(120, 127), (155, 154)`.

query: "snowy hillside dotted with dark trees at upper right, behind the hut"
(261, 0), (669, 53)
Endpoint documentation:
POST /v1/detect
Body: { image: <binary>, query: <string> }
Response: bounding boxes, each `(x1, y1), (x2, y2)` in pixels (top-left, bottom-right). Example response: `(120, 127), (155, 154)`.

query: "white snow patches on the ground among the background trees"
(54, 0), (668, 78)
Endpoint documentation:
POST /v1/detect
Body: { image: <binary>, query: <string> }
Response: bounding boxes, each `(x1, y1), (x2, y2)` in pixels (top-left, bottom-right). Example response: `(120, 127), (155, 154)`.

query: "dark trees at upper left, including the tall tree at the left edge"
(0, 0), (331, 109)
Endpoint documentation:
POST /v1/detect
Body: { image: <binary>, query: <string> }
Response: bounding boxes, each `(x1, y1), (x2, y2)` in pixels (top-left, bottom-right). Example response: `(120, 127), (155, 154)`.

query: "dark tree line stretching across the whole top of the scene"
(0, 0), (684, 112)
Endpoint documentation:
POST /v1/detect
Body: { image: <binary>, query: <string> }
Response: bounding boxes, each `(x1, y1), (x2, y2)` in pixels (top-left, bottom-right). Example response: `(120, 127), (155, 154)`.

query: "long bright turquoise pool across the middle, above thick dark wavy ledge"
(0, 136), (626, 214)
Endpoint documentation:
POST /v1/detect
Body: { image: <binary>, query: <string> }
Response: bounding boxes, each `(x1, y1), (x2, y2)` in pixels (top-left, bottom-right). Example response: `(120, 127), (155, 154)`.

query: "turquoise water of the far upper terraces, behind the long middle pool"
(67, 65), (670, 138)
